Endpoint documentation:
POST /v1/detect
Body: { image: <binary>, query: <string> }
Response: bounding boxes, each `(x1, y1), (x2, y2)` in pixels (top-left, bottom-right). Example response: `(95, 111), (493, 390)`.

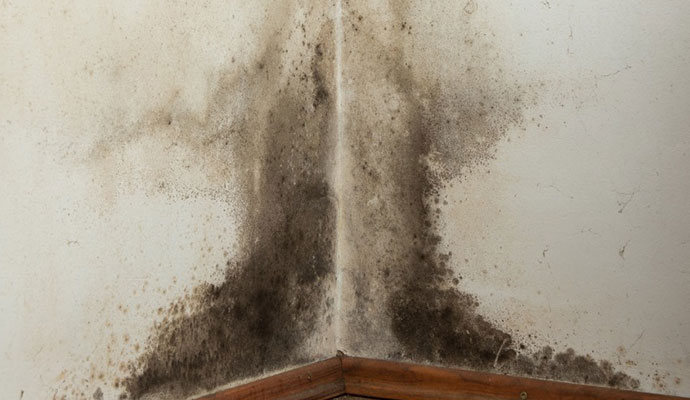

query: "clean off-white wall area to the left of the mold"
(0, 1), (266, 400)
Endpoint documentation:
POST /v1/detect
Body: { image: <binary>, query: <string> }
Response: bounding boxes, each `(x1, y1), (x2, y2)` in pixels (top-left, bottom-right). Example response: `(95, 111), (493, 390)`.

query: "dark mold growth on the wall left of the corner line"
(116, 9), (335, 399)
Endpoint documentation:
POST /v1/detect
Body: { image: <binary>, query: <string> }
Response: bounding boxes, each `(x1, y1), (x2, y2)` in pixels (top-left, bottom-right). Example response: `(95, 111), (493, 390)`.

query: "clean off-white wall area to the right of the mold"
(443, 1), (690, 396)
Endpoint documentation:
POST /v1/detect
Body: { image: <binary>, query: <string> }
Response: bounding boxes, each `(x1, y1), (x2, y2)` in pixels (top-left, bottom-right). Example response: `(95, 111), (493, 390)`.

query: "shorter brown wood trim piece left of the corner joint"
(200, 357), (345, 400)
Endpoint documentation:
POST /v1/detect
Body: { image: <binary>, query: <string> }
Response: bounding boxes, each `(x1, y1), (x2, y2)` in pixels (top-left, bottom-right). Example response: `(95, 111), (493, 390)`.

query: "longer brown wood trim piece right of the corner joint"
(342, 357), (687, 400)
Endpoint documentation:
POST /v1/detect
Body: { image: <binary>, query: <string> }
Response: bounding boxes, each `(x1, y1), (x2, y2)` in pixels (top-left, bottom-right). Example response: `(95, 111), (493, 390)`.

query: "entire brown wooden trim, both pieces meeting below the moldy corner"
(202, 354), (689, 400)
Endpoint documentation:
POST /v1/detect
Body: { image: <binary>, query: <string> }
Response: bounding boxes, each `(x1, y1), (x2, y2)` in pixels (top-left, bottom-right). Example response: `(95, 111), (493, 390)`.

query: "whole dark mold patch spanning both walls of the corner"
(115, 1), (637, 398)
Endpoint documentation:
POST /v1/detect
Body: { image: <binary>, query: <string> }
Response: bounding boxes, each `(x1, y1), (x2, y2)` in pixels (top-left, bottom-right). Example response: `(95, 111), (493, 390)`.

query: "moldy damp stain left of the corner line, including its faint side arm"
(82, 4), (336, 398)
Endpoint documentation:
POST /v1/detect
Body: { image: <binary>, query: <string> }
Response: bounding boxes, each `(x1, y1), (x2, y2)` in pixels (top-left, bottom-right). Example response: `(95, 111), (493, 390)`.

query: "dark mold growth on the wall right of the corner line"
(345, 2), (639, 388)
